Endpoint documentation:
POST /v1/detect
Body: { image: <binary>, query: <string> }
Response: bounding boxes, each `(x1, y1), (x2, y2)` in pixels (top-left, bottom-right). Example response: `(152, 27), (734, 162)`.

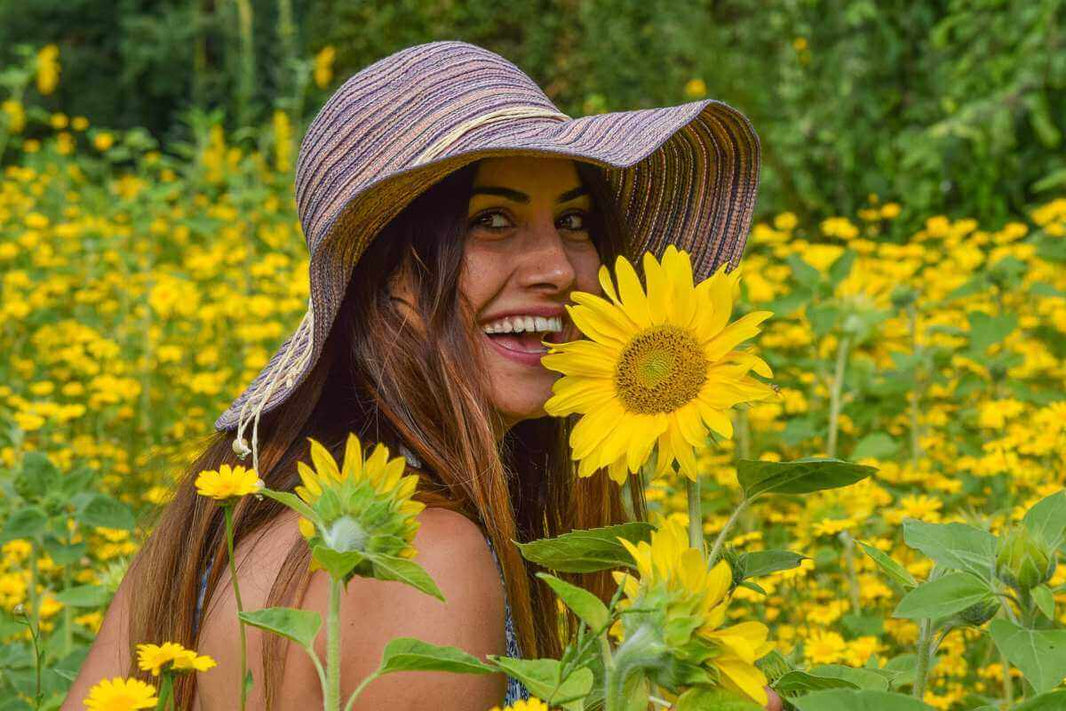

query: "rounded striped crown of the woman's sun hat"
(295, 41), (559, 254)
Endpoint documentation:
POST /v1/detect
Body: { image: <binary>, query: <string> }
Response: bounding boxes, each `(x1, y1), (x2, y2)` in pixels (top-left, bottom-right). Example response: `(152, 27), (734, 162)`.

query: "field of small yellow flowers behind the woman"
(0, 45), (1066, 710)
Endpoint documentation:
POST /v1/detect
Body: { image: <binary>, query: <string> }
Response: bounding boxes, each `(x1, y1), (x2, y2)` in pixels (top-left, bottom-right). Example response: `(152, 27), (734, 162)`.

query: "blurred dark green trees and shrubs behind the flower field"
(0, 0), (1066, 229)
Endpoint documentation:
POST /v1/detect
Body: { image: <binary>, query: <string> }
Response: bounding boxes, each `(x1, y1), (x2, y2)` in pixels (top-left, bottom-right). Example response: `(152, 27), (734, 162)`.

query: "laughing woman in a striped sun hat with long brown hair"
(67, 42), (784, 711)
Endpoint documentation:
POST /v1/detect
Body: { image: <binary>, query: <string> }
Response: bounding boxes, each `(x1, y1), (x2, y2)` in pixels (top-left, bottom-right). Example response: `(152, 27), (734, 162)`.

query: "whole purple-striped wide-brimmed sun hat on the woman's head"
(214, 41), (759, 467)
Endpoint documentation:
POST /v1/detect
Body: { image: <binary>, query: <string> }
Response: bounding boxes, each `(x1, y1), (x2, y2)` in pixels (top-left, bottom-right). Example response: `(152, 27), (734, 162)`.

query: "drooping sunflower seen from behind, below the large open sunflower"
(611, 520), (774, 705)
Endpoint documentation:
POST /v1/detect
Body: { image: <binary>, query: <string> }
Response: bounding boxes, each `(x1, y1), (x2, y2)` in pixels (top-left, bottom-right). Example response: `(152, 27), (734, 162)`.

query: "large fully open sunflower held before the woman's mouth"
(542, 245), (776, 484)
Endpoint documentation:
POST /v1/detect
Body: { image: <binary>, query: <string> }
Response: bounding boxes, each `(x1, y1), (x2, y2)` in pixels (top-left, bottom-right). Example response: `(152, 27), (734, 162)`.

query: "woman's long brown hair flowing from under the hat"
(129, 162), (645, 709)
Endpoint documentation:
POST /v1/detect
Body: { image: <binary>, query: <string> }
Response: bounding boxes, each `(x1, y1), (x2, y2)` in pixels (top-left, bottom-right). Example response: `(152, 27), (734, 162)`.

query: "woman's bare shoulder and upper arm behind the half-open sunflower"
(281, 508), (506, 711)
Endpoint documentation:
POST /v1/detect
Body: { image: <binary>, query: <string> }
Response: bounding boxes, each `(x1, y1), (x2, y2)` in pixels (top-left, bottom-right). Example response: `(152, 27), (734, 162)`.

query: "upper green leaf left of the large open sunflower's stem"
(515, 521), (655, 572)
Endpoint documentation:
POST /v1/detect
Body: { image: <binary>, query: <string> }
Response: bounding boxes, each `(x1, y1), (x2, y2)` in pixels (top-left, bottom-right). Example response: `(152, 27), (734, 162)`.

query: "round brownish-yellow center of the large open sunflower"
(614, 324), (707, 415)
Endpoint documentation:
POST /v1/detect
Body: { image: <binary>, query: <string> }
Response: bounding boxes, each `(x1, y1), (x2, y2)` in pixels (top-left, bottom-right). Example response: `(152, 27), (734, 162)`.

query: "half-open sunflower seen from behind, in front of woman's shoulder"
(294, 433), (425, 575)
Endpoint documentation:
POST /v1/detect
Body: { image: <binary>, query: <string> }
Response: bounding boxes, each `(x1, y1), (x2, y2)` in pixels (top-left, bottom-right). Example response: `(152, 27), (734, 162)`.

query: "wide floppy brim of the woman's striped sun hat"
(214, 99), (760, 431)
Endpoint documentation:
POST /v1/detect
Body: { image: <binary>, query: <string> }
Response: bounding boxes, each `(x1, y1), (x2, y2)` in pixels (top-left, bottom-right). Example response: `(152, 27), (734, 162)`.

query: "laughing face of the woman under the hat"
(459, 157), (600, 427)
